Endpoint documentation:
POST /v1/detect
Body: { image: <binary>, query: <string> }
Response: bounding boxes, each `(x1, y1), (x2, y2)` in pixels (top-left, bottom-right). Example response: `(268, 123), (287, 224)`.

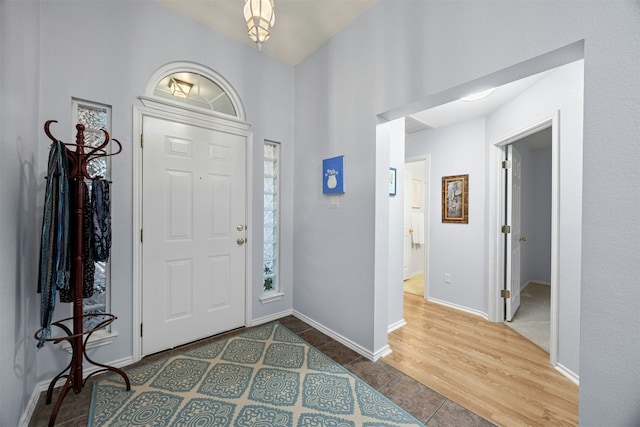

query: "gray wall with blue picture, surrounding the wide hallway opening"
(294, 1), (640, 425)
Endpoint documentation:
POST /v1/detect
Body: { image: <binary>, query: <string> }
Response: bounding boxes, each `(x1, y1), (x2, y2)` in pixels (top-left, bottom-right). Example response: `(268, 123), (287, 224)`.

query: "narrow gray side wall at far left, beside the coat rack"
(0, 1), (44, 426)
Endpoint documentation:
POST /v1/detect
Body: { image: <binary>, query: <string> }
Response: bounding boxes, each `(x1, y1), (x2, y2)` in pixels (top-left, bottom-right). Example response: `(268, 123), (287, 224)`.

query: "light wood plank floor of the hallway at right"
(383, 292), (578, 426)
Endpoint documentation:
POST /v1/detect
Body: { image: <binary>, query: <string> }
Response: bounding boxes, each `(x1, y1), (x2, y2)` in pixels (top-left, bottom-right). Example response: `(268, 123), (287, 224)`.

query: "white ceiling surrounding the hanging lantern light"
(157, 0), (375, 65)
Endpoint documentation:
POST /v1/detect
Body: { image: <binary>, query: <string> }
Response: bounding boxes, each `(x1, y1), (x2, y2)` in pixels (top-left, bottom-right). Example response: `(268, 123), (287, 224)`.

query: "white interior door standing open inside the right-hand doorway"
(505, 145), (525, 321)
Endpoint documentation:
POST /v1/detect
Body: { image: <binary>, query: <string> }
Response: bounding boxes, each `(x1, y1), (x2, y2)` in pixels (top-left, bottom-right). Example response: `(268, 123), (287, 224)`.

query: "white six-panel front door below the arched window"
(142, 117), (247, 355)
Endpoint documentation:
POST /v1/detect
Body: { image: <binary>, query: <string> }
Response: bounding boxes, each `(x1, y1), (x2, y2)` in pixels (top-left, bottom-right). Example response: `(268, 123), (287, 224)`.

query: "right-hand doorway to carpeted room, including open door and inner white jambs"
(496, 123), (559, 360)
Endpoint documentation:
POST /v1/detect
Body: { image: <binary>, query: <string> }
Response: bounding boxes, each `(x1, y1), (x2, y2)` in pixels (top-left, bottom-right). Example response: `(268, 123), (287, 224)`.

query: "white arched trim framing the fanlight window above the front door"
(144, 61), (247, 120)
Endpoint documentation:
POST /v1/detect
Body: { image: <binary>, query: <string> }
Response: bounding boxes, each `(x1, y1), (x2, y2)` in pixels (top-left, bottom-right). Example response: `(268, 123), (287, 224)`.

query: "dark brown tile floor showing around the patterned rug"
(29, 316), (493, 427)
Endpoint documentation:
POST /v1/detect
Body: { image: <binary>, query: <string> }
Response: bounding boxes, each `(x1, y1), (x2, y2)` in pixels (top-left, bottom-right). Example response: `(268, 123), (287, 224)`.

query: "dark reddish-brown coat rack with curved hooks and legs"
(35, 120), (131, 426)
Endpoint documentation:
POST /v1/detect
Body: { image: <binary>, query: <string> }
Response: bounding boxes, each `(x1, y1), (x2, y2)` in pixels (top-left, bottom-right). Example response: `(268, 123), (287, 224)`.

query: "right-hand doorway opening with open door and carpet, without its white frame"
(504, 127), (553, 353)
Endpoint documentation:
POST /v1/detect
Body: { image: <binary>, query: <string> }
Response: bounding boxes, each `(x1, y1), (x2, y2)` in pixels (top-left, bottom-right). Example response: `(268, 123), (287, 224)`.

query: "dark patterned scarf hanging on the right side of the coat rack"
(91, 179), (111, 261)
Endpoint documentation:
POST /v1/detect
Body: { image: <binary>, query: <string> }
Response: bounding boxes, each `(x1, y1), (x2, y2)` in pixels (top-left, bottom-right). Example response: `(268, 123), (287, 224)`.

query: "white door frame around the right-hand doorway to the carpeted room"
(488, 111), (560, 366)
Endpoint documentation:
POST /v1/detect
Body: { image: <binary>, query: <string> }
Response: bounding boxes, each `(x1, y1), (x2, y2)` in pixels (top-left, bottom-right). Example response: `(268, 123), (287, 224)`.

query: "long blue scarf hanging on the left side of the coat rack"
(38, 141), (70, 347)
